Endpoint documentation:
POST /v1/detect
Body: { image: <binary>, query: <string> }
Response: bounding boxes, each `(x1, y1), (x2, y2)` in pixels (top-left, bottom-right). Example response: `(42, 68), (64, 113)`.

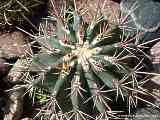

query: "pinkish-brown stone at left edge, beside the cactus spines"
(0, 32), (31, 58)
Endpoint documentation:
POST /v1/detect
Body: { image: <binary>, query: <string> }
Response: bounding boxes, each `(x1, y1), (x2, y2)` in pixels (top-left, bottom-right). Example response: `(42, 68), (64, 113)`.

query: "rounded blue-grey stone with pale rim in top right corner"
(120, 0), (160, 32)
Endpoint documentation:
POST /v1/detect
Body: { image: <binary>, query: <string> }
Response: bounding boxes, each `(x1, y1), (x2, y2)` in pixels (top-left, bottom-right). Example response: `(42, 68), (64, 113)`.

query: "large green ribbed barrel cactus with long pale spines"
(30, 0), (160, 120)
